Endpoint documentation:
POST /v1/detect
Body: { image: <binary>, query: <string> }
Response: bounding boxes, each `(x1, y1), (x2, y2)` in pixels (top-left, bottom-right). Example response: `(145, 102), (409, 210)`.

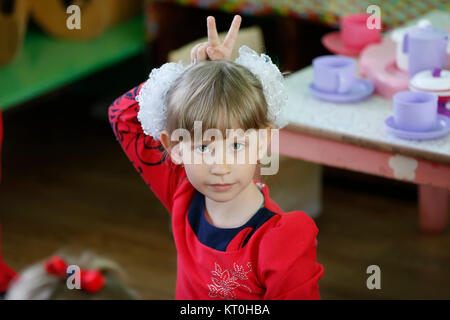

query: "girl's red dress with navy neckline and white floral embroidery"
(109, 84), (324, 300)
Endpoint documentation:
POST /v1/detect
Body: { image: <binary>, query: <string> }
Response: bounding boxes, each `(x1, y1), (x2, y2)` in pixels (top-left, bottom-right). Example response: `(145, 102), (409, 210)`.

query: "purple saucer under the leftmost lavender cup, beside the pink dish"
(309, 78), (374, 103)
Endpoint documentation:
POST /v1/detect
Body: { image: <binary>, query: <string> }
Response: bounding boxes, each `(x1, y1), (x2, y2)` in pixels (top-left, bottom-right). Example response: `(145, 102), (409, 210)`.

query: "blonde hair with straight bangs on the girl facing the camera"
(166, 60), (271, 149)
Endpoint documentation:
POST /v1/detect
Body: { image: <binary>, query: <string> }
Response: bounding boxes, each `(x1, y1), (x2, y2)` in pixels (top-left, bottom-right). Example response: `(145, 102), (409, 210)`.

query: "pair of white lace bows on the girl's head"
(136, 45), (288, 140)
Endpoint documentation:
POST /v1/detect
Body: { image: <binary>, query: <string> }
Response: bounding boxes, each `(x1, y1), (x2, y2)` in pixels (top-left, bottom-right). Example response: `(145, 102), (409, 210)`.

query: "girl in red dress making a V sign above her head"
(109, 16), (323, 299)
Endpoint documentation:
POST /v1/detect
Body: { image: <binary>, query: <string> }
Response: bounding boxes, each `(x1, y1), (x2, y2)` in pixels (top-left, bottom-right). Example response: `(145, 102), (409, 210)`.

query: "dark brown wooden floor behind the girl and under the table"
(0, 63), (450, 299)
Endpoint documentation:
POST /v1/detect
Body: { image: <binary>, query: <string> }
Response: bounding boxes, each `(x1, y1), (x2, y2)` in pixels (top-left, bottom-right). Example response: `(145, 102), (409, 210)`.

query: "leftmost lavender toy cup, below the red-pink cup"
(312, 55), (355, 94)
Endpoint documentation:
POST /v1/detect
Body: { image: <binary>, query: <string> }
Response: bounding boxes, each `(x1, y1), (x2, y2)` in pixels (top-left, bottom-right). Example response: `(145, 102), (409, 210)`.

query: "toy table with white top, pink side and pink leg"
(279, 66), (450, 232)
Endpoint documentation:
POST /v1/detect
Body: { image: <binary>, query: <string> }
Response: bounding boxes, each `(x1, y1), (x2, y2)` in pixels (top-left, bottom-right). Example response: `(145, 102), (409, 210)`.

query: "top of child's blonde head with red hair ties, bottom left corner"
(5, 251), (138, 300)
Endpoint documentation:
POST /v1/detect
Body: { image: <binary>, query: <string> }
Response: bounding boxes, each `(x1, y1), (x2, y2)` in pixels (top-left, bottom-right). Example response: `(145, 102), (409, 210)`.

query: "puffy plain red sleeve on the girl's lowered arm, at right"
(258, 211), (324, 300)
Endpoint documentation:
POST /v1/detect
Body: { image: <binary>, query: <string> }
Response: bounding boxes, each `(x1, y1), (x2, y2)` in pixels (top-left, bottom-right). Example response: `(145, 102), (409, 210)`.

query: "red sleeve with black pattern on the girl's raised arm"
(108, 83), (186, 212)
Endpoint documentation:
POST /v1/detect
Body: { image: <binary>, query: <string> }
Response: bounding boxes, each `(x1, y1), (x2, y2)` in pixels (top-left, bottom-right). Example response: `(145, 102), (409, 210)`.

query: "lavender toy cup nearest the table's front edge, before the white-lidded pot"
(394, 91), (438, 131)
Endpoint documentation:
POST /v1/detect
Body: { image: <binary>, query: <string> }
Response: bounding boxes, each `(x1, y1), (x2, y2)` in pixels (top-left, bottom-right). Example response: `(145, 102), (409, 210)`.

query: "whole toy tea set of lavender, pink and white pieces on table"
(309, 14), (450, 140)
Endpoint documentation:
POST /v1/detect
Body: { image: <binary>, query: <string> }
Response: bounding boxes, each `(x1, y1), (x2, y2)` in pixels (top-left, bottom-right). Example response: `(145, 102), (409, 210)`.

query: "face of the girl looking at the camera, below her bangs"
(161, 117), (273, 202)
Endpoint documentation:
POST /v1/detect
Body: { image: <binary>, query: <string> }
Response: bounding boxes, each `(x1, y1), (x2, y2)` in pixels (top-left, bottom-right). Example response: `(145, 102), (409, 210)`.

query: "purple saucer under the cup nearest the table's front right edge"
(384, 114), (450, 140)
